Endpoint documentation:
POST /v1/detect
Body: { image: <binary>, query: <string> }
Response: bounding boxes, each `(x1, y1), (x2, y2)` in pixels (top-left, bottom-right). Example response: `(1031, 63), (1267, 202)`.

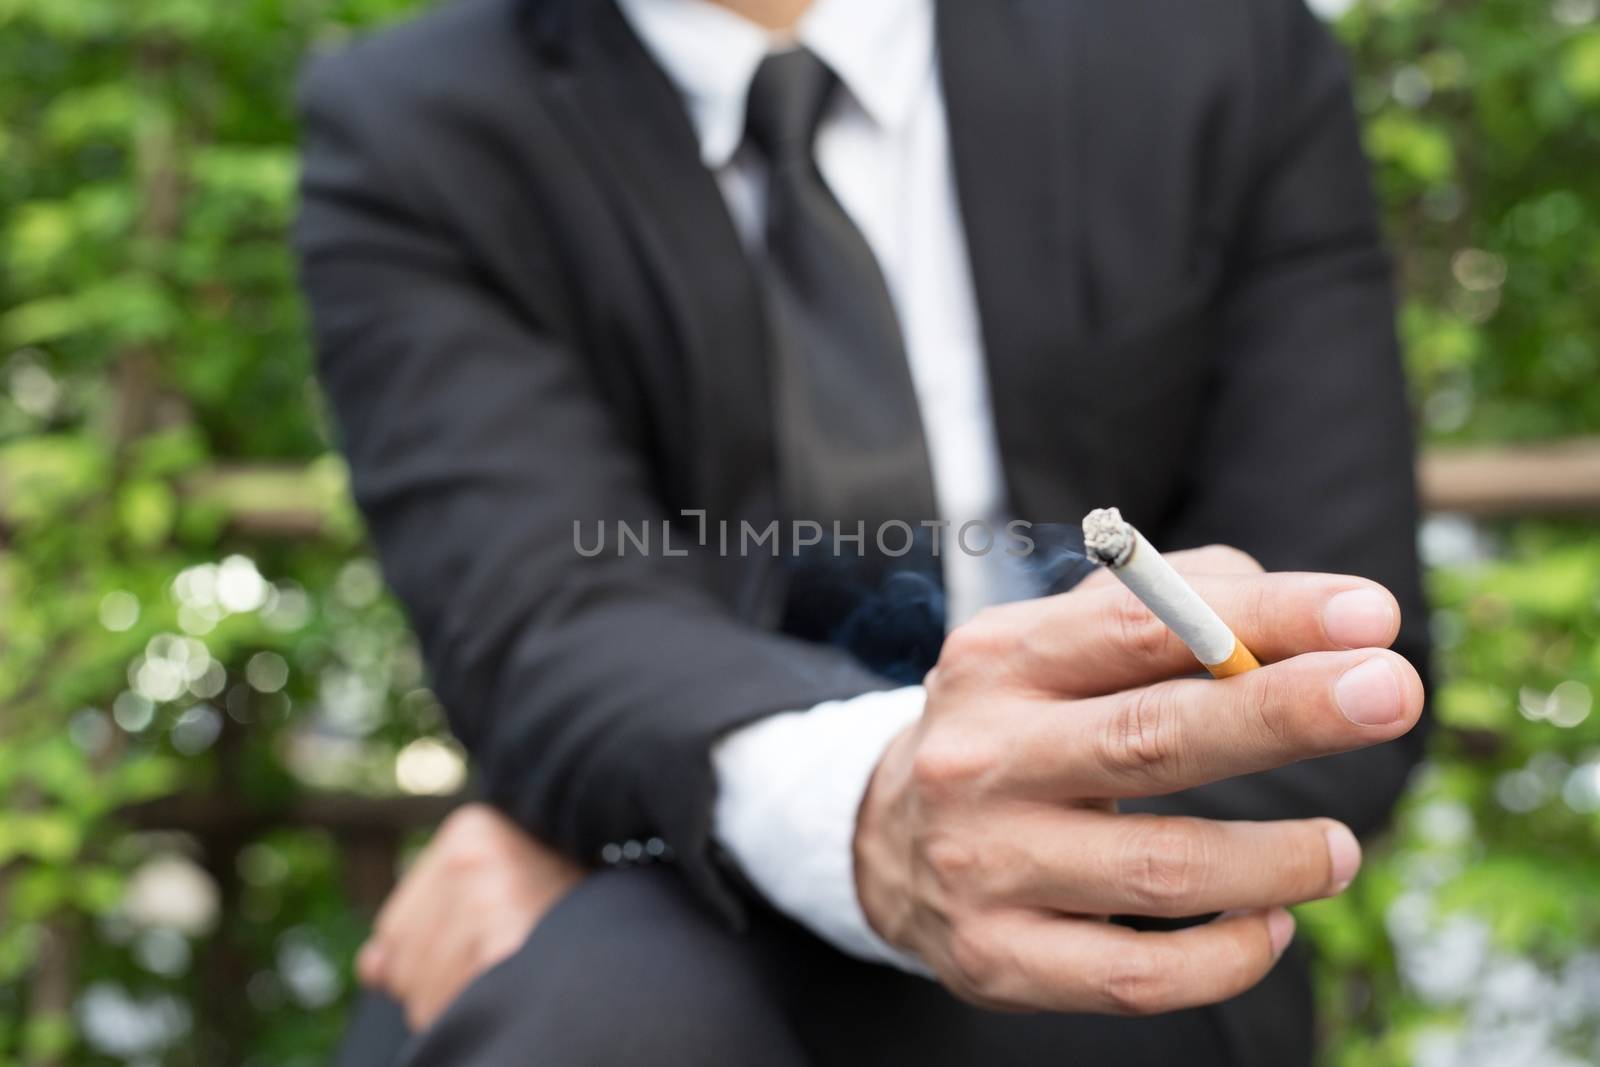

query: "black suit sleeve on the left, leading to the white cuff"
(296, 61), (888, 921)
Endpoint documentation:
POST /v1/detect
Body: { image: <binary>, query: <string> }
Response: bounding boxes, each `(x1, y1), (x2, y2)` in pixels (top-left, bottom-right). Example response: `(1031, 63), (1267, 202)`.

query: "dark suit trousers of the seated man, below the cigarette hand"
(371, 869), (1310, 1067)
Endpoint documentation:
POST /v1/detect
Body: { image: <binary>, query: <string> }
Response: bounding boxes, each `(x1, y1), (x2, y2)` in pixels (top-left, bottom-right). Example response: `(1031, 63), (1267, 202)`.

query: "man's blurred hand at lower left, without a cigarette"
(355, 805), (584, 1033)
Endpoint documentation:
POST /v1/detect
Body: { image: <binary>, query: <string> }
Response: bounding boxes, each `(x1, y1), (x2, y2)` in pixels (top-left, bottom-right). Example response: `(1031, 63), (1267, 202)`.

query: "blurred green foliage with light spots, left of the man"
(0, 0), (442, 1067)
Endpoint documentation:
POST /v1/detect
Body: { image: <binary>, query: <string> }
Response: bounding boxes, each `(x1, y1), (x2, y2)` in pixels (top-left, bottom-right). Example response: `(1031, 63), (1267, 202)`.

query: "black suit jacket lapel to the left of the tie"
(531, 0), (773, 531)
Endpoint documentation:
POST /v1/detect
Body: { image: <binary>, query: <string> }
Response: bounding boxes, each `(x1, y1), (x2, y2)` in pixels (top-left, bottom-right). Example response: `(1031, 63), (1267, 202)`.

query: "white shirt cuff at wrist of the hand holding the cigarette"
(712, 686), (931, 976)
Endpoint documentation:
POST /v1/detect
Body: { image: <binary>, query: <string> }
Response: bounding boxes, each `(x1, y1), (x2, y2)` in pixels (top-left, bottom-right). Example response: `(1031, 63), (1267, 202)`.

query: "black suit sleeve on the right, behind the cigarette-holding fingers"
(1132, 0), (1429, 833)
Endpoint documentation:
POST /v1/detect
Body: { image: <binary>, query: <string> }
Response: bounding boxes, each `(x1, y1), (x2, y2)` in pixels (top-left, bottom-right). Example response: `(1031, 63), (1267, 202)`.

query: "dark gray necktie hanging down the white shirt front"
(746, 50), (944, 681)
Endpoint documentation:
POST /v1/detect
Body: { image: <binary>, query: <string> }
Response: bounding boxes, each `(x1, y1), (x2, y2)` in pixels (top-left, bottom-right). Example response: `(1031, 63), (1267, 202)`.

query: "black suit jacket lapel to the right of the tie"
(938, 0), (1098, 522)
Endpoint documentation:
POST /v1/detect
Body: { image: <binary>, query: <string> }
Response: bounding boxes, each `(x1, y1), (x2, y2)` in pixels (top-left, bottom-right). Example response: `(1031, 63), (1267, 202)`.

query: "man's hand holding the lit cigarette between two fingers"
(854, 549), (1422, 1014)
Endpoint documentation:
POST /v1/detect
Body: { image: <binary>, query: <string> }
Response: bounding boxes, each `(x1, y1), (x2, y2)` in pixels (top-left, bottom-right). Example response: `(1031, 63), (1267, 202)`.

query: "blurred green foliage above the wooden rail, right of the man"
(1341, 0), (1600, 440)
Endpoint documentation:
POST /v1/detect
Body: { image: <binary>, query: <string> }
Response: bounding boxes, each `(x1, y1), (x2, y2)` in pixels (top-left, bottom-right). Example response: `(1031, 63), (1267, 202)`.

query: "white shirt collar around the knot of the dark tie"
(618, 0), (934, 170)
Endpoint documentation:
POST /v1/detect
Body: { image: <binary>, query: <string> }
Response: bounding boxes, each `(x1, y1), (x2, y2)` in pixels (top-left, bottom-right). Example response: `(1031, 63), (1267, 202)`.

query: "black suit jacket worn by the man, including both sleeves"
(298, 0), (1424, 953)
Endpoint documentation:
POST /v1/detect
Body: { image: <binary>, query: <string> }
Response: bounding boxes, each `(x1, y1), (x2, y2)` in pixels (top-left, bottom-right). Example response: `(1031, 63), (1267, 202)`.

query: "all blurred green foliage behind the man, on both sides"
(0, 0), (1600, 1067)
